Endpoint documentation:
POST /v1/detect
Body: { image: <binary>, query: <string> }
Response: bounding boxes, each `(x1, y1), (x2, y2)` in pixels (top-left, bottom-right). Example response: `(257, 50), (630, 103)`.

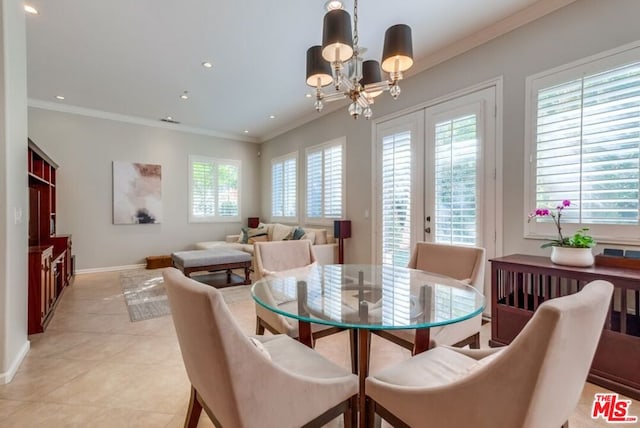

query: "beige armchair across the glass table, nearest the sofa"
(254, 239), (342, 342)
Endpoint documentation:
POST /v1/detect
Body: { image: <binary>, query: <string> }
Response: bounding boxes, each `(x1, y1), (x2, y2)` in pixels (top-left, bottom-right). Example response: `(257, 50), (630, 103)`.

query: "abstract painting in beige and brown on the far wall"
(113, 161), (162, 224)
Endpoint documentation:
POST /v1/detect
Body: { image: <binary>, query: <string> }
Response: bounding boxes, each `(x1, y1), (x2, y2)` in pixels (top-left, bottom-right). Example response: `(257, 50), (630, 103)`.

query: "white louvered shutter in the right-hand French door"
(434, 114), (479, 245)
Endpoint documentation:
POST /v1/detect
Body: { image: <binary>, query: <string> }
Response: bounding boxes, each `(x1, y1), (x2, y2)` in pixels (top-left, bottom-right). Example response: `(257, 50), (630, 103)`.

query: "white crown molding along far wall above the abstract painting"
(27, 98), (258, 143)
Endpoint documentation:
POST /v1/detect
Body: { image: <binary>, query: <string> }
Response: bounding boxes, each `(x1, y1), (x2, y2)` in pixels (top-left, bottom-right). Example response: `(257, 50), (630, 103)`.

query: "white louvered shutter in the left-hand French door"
(381, 131), (412, 266)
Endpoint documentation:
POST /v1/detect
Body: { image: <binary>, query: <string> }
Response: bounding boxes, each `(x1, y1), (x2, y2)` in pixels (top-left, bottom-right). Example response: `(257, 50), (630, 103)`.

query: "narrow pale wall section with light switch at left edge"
(0, 0), (29, 383)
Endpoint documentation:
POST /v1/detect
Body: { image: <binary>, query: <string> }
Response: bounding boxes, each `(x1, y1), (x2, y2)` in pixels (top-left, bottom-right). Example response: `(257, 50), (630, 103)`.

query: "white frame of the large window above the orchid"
(522, 41), (640, 245)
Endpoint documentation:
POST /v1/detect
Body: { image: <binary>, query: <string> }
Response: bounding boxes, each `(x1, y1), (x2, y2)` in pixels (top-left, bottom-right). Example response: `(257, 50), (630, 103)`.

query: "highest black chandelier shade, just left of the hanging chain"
(322, 9), (353, 62)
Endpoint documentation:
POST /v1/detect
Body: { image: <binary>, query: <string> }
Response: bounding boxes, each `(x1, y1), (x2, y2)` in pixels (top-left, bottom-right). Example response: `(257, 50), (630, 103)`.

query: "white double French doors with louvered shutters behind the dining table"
(374, 86), (501, 304)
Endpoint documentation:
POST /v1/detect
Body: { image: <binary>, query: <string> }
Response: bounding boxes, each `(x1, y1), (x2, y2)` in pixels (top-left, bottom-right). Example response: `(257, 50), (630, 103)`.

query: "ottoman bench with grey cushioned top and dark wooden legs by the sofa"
(171, 247), (251, 284)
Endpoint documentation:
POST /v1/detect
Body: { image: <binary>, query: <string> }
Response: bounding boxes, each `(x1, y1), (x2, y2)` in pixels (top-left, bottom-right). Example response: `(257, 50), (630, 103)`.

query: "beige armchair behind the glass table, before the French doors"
(372, 242), (485, 352)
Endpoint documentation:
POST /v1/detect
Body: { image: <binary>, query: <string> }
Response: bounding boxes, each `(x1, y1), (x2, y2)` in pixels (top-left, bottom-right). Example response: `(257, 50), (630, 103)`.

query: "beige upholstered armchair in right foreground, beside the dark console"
(365, 281), (613, 428)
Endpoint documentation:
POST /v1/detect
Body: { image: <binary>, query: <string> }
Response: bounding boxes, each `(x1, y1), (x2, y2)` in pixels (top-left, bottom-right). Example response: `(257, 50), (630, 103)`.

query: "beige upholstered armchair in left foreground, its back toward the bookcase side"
(163, 268), (358, 428)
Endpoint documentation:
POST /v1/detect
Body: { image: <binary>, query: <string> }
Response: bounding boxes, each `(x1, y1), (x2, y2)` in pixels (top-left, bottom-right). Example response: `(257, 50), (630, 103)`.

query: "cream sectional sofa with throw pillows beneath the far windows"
(195, 223), (338, 274)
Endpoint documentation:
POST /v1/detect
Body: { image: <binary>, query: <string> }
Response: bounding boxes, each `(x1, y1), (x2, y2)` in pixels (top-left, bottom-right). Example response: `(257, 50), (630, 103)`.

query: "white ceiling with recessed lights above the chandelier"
(26, 0), (572, 141)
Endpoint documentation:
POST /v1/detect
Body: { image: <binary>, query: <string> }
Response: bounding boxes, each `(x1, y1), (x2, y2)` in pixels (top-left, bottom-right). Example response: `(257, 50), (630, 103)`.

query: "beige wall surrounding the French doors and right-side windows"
(261, 0), (640, 263)
